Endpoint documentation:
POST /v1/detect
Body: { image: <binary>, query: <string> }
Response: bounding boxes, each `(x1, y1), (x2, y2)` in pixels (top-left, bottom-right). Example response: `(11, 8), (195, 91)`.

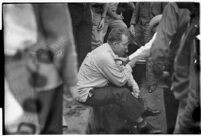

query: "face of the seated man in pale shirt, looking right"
(113, 35), (129, 57)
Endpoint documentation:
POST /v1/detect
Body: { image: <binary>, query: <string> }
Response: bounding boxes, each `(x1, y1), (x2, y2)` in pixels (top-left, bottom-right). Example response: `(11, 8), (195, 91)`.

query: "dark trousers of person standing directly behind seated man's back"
(68, 3), (92, 66)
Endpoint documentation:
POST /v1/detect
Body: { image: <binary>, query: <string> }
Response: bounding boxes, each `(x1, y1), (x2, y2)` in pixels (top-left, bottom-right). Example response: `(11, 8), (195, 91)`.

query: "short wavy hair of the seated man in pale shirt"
(107, 28), (130, 44)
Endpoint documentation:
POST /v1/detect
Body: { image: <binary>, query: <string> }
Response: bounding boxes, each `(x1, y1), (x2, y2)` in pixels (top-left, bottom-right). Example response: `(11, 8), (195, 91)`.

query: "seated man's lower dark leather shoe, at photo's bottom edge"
(137, 122), (162, 134)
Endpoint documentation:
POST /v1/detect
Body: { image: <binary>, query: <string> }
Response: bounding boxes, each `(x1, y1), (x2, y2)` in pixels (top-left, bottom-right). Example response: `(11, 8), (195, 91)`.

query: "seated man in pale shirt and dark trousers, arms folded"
(71, 28), (161, 134)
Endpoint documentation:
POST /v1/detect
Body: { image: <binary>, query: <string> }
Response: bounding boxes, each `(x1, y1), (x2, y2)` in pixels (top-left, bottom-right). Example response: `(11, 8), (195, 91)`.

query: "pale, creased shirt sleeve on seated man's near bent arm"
(97, 57), (132, 86)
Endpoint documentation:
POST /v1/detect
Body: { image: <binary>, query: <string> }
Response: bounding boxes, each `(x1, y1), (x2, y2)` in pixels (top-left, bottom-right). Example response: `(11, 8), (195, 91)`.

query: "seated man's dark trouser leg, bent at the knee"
(81, 86), (144, 122)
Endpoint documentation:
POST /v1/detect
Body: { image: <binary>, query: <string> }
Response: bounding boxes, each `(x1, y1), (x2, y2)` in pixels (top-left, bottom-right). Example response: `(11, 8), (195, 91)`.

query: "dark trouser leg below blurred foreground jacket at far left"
(37, 85), (63, 134)
